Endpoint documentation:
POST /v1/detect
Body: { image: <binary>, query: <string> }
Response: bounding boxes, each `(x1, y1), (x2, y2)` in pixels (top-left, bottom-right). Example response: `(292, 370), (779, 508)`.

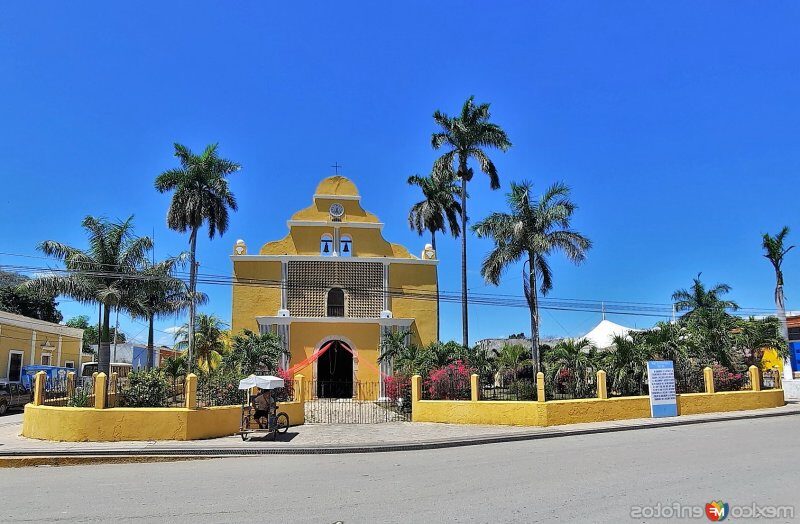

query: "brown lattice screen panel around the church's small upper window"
(286, 260), (383, 318)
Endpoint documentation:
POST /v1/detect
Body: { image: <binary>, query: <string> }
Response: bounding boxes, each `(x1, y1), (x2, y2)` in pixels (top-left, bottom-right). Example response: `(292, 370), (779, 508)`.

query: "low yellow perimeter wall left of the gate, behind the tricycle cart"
(22, 402), (305, 442)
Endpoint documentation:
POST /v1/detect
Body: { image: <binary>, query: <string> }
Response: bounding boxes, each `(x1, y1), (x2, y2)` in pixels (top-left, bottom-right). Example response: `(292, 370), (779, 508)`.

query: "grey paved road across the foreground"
(0, 417), (800, 522)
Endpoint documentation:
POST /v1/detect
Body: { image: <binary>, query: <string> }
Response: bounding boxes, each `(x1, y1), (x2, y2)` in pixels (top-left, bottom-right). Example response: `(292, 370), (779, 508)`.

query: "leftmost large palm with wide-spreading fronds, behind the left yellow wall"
(23, 216), (153, 374)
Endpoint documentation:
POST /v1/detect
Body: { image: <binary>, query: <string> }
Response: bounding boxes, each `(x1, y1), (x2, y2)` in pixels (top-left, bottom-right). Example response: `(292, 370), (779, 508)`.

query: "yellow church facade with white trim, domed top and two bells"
(231, 176), (438, 398)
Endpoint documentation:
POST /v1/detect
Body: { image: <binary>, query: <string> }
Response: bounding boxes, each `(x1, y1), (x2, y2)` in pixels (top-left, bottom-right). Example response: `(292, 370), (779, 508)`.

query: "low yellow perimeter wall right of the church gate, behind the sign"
(411, 389), (784, 426)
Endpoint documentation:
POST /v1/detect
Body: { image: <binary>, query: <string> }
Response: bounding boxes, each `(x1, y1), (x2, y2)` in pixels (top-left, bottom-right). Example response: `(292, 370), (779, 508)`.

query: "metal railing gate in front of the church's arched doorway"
(304, 380), (411, 424)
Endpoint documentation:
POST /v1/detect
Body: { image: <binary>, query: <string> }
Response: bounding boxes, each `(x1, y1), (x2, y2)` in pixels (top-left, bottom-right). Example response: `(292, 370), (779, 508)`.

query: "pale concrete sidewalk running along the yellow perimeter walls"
(0, 403), (800, 458)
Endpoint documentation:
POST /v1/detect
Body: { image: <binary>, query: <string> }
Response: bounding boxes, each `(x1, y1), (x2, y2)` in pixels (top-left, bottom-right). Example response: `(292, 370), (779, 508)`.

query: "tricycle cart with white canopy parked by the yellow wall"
(239, 375), (289, 440)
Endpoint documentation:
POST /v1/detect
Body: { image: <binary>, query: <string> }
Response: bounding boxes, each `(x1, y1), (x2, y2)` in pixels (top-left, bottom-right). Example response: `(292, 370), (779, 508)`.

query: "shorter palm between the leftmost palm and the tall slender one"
(128, 253), (207, 368)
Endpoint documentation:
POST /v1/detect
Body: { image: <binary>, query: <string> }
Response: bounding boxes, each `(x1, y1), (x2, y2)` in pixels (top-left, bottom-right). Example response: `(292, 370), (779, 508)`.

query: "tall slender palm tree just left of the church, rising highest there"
(155, 143), (241, 372)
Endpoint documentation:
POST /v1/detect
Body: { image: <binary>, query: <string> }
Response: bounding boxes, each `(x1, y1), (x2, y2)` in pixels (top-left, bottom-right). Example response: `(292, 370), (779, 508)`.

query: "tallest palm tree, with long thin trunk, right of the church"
(431, 96), (511, 347)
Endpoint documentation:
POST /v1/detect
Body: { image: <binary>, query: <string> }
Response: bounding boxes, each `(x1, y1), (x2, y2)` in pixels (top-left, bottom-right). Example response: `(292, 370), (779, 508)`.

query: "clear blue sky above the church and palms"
(0, 1), (800, 346)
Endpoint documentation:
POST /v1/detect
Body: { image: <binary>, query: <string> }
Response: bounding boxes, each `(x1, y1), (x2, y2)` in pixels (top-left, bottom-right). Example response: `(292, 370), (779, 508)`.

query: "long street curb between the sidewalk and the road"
(0, 410), (800, 462)
